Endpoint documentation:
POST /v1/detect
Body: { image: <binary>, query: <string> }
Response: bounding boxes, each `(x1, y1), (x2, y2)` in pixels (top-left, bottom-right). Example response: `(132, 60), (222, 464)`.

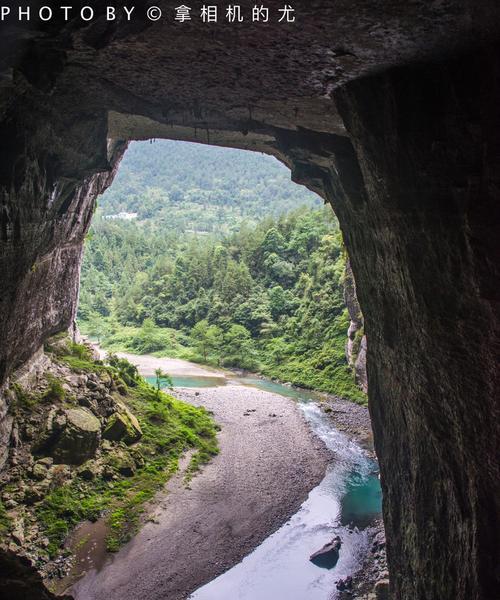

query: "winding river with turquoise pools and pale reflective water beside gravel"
(168, 377), (382, 600)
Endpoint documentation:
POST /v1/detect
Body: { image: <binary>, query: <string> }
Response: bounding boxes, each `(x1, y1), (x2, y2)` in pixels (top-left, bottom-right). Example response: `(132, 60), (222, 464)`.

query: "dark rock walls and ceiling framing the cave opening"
(0, 0), (500, 600)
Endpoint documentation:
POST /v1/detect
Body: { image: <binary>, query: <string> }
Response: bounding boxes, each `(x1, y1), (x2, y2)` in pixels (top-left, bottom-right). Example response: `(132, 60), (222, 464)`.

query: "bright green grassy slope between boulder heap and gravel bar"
(33, 342), (218, 556)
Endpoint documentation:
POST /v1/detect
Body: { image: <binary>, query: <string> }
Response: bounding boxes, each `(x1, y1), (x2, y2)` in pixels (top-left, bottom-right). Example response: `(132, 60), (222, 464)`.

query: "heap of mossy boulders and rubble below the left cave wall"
(0, 335), (144, 598)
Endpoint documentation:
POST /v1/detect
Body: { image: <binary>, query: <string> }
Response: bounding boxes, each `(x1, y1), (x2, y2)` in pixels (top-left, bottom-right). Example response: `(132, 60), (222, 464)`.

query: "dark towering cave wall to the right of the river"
(333, 51), (500, 600)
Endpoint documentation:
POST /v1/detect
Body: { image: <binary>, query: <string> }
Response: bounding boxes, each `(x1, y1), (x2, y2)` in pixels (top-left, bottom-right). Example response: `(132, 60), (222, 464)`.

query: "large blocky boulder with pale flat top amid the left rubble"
(49, 408), (101, 465)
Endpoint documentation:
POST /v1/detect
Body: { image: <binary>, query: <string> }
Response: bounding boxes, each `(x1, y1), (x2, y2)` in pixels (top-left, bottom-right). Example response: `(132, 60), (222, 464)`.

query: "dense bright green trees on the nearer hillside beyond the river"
(79, 141), (364, 401)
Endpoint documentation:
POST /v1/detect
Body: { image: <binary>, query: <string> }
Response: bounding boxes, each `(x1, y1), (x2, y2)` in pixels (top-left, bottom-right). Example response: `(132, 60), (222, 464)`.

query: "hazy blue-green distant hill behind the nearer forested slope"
(99, 140), (322, 233)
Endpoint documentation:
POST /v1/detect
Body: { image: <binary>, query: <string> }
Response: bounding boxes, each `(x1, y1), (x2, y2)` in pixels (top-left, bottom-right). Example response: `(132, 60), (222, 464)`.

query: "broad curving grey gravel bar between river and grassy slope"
(72, 384), (330, 600)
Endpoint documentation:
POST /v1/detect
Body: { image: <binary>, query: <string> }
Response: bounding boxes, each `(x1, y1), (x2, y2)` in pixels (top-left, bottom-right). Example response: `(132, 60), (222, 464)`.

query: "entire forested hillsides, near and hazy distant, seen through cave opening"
(79, 142), (365, 402)
